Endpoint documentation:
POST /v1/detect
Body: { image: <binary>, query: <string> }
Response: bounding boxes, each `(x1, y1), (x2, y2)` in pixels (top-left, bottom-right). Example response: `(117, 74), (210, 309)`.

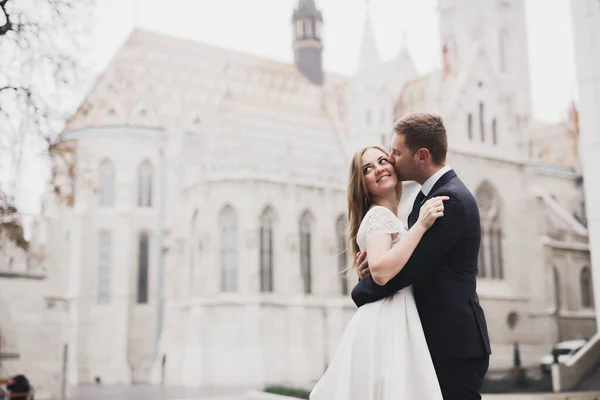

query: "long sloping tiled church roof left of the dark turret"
(66, 30), (346, 131)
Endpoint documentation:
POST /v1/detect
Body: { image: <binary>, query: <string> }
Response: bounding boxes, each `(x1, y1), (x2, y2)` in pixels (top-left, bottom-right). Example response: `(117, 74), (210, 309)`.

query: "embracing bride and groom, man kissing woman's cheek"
(310, 114), (491, 400)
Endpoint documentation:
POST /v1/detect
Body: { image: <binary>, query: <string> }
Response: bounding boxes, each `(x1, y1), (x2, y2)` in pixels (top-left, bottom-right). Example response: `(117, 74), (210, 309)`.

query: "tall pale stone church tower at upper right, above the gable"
(438, 0), (531, 147)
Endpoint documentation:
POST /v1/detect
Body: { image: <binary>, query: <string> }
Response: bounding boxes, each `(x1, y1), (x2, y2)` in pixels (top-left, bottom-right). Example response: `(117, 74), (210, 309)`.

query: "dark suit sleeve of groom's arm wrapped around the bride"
(352, 193), (466, 307)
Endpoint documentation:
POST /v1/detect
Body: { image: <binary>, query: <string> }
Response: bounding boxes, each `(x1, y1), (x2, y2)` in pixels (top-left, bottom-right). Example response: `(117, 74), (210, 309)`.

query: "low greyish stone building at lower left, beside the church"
(0, 236), (66, 399)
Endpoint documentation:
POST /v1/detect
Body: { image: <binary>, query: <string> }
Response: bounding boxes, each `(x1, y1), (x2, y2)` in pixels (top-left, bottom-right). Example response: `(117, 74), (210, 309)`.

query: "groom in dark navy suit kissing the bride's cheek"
(352, 114), (491, 400)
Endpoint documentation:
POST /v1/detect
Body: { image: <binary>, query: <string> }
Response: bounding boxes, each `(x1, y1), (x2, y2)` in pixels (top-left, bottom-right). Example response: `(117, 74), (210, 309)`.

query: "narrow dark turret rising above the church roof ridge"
(292, 0), (324, 86)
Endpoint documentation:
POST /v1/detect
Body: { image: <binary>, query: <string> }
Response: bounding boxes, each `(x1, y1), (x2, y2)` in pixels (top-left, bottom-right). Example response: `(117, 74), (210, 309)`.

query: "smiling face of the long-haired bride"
(362, 149), (398, 198)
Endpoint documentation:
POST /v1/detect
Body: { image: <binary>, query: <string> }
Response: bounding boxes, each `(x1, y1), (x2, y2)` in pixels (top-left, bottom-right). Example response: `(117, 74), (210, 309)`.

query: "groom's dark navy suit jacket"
(352, 170), (491, 361)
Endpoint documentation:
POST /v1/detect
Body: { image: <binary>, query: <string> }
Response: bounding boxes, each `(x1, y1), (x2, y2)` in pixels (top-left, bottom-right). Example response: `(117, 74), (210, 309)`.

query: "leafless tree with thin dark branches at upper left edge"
(0, 0), (94, 247)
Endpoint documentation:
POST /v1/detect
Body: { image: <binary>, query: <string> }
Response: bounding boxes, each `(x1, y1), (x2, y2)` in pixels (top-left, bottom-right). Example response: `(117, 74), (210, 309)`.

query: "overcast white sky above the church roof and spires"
(94, 0), (576, 122)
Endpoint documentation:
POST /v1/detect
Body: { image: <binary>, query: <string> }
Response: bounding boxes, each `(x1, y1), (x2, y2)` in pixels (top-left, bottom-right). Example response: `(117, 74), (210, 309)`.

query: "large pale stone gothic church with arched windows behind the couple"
(38, 0), (595, 386)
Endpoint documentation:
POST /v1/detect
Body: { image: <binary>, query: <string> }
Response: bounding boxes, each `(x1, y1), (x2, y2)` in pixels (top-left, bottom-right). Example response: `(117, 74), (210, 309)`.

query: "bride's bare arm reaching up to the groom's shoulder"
(367, 197), (447, 286)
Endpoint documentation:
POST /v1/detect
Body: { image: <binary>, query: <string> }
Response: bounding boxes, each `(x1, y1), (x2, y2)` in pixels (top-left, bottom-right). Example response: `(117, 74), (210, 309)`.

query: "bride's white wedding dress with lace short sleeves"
(310, 206), (442, 400)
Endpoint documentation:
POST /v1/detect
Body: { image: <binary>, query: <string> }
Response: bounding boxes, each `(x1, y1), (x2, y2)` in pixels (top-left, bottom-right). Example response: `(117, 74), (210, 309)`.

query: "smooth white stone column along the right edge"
(571, 0), (600, 326)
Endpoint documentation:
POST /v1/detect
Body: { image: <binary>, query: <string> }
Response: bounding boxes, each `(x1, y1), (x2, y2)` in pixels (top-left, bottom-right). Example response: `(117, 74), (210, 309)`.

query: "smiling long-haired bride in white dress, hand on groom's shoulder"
(310, 146), (448, 400)
